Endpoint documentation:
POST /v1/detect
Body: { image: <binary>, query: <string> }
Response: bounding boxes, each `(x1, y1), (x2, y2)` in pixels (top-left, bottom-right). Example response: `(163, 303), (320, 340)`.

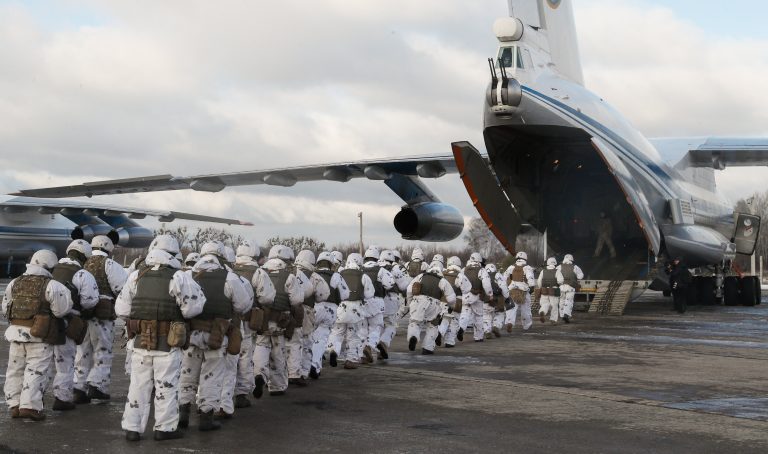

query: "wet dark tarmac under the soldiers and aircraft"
(0, 294), (768, 453)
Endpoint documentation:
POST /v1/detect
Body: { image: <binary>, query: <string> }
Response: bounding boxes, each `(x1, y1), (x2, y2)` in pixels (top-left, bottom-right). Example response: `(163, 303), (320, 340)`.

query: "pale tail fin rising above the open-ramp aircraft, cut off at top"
(508, 0), (584, 85)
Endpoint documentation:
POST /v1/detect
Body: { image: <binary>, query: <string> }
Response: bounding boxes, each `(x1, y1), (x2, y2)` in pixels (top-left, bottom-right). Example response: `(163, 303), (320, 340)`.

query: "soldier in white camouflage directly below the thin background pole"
(328, 253), (376, 369)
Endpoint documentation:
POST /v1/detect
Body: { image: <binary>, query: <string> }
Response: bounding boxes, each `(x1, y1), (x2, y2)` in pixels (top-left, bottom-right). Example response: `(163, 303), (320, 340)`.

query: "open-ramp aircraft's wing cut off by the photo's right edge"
(688, 137), (768, 170)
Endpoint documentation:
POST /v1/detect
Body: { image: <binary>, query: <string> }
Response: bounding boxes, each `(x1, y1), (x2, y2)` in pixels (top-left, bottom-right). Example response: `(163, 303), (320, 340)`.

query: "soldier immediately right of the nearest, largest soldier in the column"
(179, 242), (253, 431)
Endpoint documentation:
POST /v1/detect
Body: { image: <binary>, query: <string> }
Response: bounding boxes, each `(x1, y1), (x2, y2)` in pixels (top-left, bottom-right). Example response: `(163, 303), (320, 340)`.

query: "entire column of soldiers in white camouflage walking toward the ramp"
(2, 239), (583, 441)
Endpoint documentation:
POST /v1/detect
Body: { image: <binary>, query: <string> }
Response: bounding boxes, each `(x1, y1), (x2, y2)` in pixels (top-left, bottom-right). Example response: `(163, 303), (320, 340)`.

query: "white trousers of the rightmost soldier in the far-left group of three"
(75, 318), (115, 394)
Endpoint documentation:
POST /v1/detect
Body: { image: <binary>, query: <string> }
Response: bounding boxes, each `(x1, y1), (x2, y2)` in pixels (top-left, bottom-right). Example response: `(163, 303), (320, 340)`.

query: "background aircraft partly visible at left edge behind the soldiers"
(0, 196), (249, 277)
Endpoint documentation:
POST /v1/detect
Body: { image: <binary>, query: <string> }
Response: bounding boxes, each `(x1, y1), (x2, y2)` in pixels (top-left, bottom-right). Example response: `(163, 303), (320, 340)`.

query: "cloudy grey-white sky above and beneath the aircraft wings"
(0, 0), (768, 248)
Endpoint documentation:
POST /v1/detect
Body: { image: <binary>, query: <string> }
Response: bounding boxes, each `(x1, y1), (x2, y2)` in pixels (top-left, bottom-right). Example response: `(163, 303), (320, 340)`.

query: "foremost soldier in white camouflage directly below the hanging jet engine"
(406, 261), (456, 355)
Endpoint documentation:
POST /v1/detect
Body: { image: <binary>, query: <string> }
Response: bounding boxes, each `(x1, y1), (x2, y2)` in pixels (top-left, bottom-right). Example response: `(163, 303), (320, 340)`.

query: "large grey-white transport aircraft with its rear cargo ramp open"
(12, 0), (768, 304)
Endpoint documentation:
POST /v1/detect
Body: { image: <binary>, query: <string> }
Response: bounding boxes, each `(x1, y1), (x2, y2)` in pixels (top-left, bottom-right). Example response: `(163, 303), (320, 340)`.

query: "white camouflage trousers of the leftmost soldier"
(3, 342), (53, 410)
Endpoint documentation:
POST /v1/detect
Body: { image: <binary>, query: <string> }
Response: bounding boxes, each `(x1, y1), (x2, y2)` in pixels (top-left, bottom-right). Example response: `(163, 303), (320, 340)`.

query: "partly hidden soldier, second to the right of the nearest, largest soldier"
(224, 240), (275, 411)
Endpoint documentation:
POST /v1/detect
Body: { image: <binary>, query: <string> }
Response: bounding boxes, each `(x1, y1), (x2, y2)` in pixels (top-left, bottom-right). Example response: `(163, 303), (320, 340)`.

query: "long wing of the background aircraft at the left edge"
(0, 197), (253, 225)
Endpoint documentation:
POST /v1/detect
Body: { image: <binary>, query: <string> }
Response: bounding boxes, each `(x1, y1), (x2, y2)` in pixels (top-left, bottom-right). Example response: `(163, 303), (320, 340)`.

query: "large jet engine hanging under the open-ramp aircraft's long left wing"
(395, 202), (464, 241)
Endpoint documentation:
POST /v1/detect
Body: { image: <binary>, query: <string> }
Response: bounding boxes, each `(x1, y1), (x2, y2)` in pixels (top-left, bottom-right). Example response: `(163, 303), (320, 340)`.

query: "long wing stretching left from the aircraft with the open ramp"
(12, 155), (457, 198)
